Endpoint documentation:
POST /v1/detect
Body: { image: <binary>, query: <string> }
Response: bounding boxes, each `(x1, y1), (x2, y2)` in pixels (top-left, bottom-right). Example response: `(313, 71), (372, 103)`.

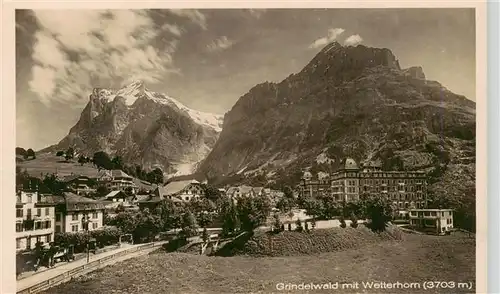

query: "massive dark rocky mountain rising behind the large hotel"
(199, 42), (475, 215)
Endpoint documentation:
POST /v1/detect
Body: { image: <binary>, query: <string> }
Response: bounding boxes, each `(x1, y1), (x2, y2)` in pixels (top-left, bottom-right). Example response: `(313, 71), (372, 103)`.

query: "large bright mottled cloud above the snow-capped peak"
(29, 10), (182, 105)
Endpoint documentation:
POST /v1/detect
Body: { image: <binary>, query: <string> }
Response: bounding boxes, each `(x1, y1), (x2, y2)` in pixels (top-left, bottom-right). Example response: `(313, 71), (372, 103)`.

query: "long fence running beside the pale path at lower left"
(17, 242), (163, 294)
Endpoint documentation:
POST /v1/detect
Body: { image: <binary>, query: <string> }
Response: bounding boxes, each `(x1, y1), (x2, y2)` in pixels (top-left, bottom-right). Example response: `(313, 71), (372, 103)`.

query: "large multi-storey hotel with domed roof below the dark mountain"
(298, 158), (427, 211)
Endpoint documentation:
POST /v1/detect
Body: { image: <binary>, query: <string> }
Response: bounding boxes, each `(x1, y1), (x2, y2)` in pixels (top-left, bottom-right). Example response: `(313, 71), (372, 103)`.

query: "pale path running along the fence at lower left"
(17, 242), (165, 292)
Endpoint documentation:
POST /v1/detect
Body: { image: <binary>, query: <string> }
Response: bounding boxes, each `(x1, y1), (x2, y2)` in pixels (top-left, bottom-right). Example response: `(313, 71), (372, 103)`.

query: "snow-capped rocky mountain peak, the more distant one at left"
(43, 81), (222, 175)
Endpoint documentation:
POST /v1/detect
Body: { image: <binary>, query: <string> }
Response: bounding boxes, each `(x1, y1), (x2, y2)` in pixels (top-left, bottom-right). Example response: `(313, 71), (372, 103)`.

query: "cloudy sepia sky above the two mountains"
(16, 8), (476, 150)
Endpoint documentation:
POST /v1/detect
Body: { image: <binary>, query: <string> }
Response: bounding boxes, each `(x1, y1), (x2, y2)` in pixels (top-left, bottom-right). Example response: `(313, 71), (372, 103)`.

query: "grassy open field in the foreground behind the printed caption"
(47, 234), (475, 294)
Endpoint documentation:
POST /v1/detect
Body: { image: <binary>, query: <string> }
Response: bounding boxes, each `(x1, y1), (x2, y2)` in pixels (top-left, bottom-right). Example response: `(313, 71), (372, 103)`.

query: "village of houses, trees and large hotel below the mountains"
(16, 153), (454, 292)
